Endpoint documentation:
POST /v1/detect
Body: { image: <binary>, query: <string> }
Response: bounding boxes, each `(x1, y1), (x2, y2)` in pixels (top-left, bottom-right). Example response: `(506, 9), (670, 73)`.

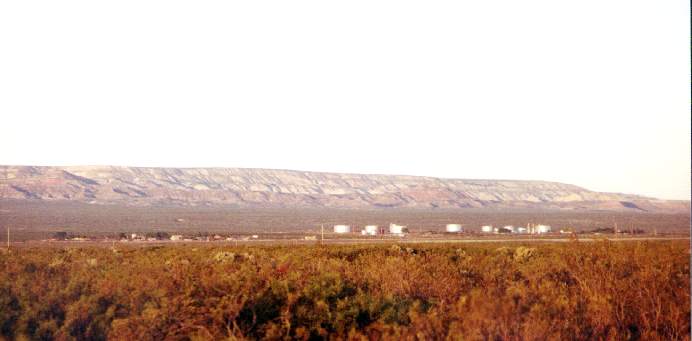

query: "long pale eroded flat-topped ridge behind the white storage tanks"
(0, 166), (689, 211)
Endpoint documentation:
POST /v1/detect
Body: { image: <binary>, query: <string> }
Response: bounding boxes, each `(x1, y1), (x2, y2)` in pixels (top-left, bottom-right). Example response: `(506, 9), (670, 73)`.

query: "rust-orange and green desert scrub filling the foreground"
(0, 241), (690, 340)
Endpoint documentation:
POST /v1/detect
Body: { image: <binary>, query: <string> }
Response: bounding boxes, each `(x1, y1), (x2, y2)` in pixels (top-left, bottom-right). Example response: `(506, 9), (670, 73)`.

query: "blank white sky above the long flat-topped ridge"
(0, 0), (691, 199)
